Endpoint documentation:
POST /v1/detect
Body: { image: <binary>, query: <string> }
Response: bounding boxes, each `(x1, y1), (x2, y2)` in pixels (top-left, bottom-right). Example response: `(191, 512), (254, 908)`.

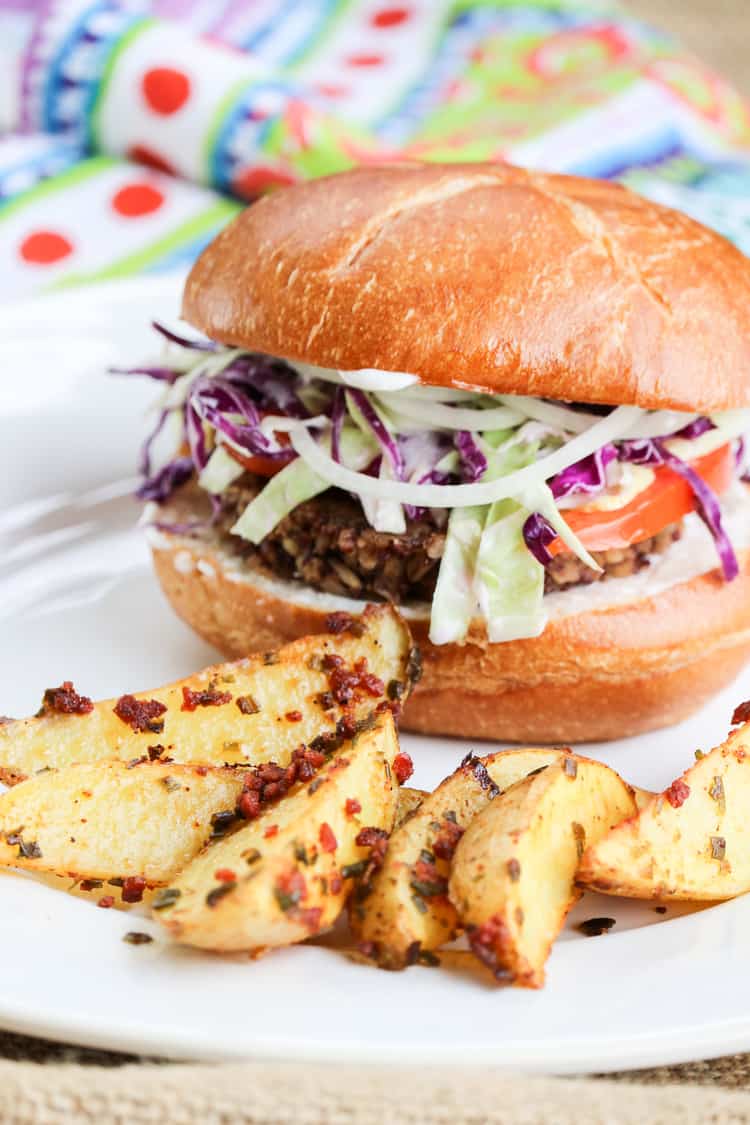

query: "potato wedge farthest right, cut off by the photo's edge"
(577, 725), (750, 902)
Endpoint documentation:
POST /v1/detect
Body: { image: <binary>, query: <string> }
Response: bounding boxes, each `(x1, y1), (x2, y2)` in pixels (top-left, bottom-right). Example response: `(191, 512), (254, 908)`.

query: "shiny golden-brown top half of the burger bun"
(182, 163), (750, 412)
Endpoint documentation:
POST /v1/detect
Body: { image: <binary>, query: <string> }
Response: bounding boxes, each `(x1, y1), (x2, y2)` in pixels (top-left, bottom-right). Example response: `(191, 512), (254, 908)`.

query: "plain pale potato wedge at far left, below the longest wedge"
(0, 762), (243, 894)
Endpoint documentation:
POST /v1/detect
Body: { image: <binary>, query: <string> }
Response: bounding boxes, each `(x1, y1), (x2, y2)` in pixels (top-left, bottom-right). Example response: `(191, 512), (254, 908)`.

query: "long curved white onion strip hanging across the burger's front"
(290, 406), (642, 507)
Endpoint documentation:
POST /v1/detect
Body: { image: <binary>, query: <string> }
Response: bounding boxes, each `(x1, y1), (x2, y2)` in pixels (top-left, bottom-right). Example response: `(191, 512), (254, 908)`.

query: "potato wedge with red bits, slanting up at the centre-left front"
(154, 711), (399, 952)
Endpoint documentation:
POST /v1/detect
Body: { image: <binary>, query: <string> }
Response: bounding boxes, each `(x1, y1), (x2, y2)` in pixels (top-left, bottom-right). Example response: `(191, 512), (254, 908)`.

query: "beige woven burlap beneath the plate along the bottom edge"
(0, 1030), (750, 1125)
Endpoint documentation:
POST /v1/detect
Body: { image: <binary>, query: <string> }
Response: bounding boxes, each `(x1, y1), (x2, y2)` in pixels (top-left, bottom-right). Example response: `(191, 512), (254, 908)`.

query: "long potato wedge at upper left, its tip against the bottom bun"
(0, 605), (419, 784)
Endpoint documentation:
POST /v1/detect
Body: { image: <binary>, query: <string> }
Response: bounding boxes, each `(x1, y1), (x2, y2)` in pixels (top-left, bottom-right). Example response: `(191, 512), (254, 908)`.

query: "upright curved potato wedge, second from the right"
(450, 756), (636, 988)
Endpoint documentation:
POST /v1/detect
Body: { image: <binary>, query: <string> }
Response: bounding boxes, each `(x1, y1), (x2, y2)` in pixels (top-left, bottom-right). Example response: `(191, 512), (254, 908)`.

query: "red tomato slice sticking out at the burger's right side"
(548, 444), (734, 555)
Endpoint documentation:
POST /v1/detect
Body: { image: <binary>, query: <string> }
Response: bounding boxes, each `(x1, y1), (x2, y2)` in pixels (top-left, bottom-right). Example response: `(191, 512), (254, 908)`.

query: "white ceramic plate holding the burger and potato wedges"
(0, 279), (750, 1072)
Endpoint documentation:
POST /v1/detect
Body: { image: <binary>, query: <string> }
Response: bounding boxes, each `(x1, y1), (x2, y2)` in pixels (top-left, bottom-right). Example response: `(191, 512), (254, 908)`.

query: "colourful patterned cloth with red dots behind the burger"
(0, 0), (750, 297)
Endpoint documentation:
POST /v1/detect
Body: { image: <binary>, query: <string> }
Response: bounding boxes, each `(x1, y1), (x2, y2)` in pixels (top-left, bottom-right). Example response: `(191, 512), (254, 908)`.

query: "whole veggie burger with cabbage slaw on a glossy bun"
(130, 163), (750, 743)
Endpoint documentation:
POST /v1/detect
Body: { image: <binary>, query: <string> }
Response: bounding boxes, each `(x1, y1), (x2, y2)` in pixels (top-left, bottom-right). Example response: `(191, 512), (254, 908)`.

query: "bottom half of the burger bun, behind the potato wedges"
(153, 534), (750, 745)
